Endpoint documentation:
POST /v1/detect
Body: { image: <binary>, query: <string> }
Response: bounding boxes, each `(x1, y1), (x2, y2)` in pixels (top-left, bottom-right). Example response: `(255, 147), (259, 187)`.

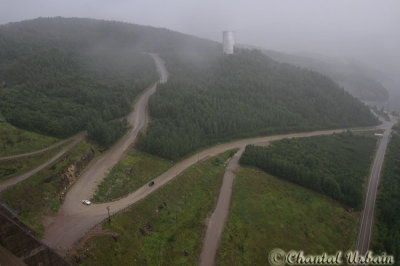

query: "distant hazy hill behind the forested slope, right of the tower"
(263, 50), (389, 102)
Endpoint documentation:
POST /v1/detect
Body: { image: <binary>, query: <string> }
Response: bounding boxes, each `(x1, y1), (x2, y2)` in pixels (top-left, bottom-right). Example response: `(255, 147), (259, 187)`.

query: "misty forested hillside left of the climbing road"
(0, 19), (158, 146)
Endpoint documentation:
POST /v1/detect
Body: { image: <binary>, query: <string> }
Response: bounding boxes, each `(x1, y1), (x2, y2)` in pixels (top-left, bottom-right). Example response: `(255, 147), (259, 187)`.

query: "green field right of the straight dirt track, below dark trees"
(217, 168), (360, 265)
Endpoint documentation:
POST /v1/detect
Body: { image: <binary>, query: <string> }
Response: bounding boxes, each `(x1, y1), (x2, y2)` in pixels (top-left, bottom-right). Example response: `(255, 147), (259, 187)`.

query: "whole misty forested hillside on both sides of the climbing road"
(0, 18), (376, 153)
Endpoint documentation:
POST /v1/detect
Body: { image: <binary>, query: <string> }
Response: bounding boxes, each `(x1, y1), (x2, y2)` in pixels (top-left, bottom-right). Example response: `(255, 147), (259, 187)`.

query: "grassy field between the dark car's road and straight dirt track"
(72, 152), (233, 265)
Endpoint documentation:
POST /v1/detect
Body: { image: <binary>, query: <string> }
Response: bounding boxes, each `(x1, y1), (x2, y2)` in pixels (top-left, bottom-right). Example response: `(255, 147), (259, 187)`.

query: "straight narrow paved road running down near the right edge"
(356, 117), (394, 254)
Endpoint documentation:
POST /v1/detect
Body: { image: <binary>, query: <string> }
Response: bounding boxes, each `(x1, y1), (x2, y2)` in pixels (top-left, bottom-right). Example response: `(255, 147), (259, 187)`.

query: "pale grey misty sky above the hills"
(0, 0), (400, 79)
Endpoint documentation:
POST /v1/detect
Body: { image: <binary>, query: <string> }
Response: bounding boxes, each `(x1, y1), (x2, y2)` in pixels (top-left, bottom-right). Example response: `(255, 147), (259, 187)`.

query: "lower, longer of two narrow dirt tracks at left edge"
(0, 132), (86, 192)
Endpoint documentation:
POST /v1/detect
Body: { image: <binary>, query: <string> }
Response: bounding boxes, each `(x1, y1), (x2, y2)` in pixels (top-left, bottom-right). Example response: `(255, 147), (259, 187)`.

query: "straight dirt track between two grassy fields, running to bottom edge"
(200, 147), (244, 266)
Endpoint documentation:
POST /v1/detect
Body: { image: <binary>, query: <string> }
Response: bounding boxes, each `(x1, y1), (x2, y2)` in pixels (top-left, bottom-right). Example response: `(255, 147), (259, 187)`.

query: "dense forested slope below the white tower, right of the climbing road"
(139, 49), (377, 159)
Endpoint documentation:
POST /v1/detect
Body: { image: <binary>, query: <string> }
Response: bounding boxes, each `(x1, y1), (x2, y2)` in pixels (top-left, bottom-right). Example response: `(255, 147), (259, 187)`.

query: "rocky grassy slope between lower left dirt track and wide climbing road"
(0, 141), (98, 237)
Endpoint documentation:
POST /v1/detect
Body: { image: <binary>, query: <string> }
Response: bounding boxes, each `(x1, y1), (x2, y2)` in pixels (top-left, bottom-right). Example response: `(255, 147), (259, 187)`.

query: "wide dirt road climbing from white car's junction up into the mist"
(43, 54), (168, 254)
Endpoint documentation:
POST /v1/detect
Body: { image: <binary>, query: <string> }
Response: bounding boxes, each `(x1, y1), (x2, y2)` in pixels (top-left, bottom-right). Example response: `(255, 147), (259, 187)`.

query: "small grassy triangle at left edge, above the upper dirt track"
(0, 122), (59, 157)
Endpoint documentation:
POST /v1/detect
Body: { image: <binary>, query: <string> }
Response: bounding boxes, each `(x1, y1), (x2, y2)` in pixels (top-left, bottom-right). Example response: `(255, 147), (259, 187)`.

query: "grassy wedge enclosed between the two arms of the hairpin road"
(93, 151), (173, 202)
